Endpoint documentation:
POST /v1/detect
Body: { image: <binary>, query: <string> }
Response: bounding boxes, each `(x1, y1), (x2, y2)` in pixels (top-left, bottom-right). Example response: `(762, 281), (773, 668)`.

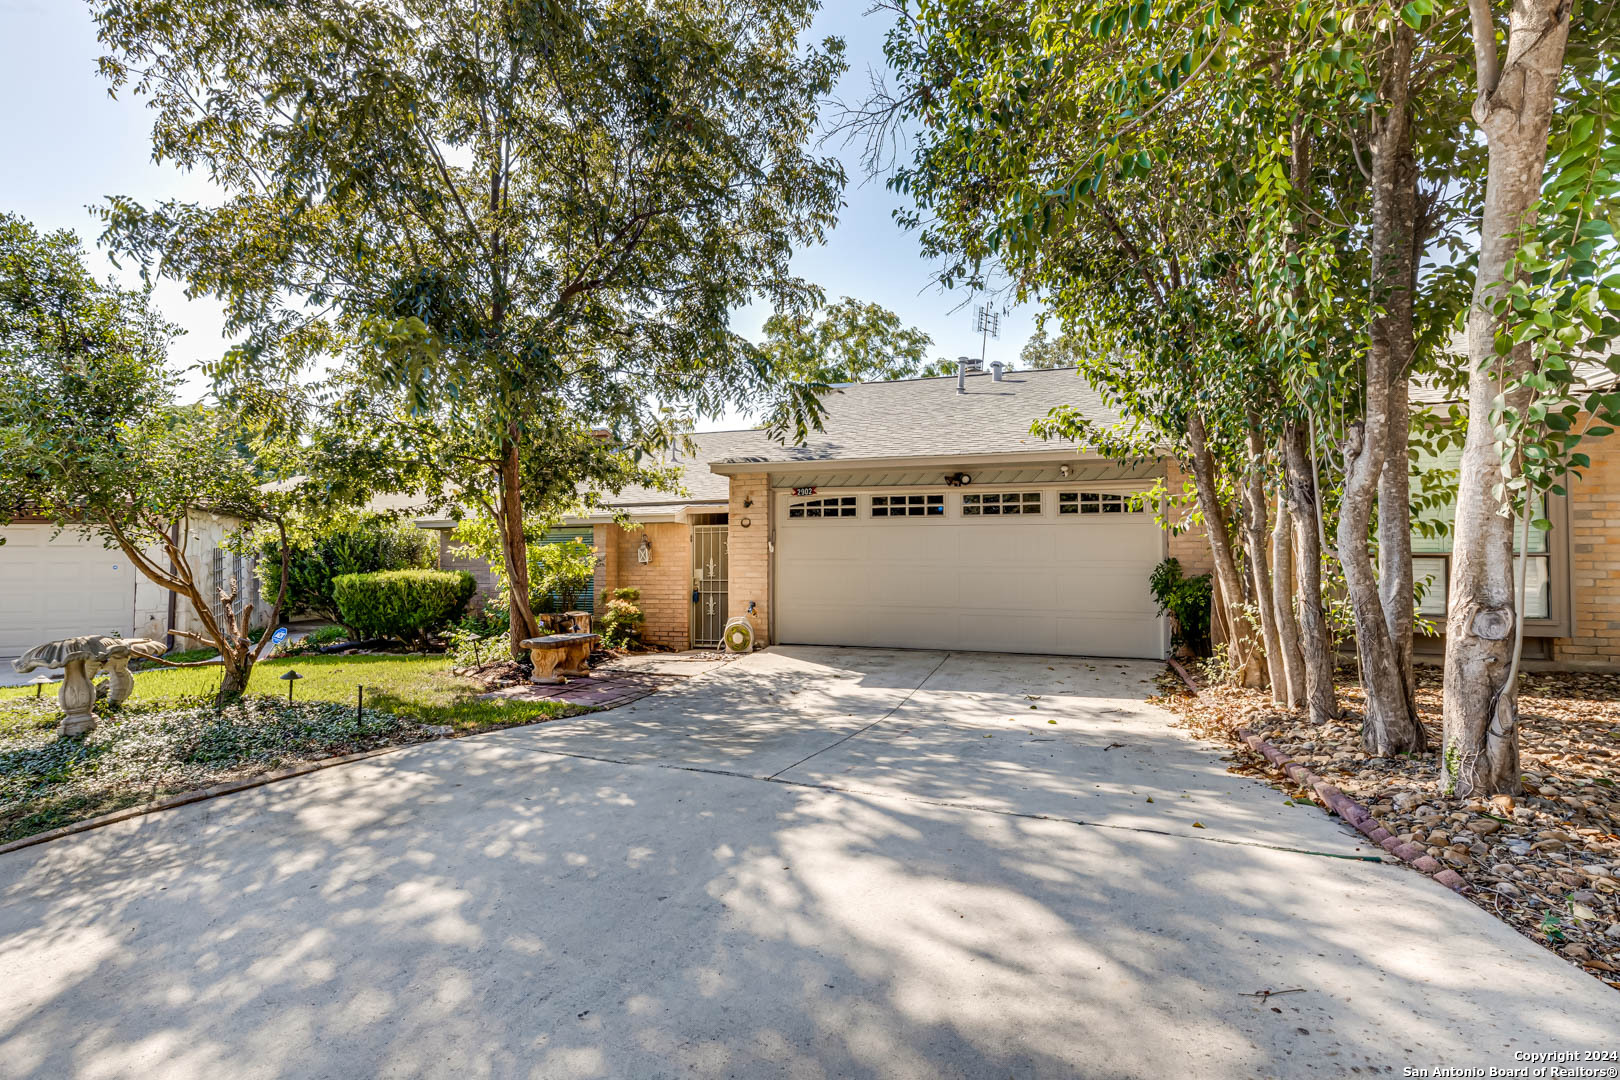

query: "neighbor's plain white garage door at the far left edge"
(0, 525), (134, 656)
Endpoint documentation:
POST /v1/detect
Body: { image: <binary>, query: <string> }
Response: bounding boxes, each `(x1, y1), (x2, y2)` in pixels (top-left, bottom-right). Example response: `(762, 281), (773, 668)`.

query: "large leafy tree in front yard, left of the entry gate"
(96, 0), (844, 644)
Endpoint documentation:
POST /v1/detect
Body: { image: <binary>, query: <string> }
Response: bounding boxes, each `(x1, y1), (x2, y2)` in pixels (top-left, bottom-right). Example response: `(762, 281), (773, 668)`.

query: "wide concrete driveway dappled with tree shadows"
(0, 648), (1620, 1080)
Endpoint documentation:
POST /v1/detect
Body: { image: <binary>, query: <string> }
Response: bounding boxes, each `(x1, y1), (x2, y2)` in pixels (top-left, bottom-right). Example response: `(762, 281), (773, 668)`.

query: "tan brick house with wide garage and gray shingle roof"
(569, 369), (1210, 657)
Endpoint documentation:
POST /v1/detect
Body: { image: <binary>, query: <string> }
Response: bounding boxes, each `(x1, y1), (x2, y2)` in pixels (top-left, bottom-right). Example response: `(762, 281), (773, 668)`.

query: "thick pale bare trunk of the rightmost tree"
(1440, 0), (1570, 797)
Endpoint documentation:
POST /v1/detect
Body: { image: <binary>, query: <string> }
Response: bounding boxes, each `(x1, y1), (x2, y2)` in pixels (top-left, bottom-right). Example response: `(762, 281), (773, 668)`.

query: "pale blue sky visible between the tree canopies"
(0, 0), (1035, 427)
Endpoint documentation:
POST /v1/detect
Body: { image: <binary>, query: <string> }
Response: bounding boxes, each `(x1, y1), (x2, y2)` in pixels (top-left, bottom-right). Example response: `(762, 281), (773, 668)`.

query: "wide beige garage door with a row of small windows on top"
(776, 486), (1170, 657)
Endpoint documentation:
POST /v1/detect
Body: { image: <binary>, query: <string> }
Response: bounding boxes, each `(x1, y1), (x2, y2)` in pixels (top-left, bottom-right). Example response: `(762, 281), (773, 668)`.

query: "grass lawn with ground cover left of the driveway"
(0, 656), (590, 844)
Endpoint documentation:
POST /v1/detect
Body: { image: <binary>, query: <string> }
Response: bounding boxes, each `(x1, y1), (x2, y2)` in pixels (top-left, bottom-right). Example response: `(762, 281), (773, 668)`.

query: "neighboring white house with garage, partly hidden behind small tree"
(0, 512), (269, 657)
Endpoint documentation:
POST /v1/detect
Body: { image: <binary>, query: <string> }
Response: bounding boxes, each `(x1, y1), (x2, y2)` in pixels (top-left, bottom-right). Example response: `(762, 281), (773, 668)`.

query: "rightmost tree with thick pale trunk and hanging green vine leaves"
(1442, 0), (1620, 795)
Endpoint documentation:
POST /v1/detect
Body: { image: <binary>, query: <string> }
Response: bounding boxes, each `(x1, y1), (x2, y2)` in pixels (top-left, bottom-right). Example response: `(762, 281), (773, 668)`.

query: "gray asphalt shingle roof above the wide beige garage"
(606, 368), (1119, 507)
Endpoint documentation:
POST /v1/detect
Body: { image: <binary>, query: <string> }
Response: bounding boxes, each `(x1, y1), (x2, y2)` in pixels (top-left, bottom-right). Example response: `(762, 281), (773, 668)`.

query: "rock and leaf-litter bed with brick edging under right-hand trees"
(1160, 669), (1620, 989)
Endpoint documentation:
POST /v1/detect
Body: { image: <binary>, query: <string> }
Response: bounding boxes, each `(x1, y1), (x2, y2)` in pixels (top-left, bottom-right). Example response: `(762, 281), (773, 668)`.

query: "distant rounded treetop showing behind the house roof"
(761, 296), (933, 385)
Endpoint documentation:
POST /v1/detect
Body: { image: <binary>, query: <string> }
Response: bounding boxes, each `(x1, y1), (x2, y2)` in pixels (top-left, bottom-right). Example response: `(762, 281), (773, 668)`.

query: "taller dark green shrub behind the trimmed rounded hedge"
(254, 513), (439, 633)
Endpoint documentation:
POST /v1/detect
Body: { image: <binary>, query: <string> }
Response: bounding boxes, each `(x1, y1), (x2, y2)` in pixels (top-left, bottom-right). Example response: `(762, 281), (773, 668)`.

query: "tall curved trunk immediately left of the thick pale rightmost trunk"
(1337, 21), (1426, 756)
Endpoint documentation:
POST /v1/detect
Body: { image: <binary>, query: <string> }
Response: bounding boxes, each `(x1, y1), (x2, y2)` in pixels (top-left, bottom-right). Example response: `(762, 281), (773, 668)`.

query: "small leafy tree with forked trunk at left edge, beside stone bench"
(0, 215), (295, 695)
